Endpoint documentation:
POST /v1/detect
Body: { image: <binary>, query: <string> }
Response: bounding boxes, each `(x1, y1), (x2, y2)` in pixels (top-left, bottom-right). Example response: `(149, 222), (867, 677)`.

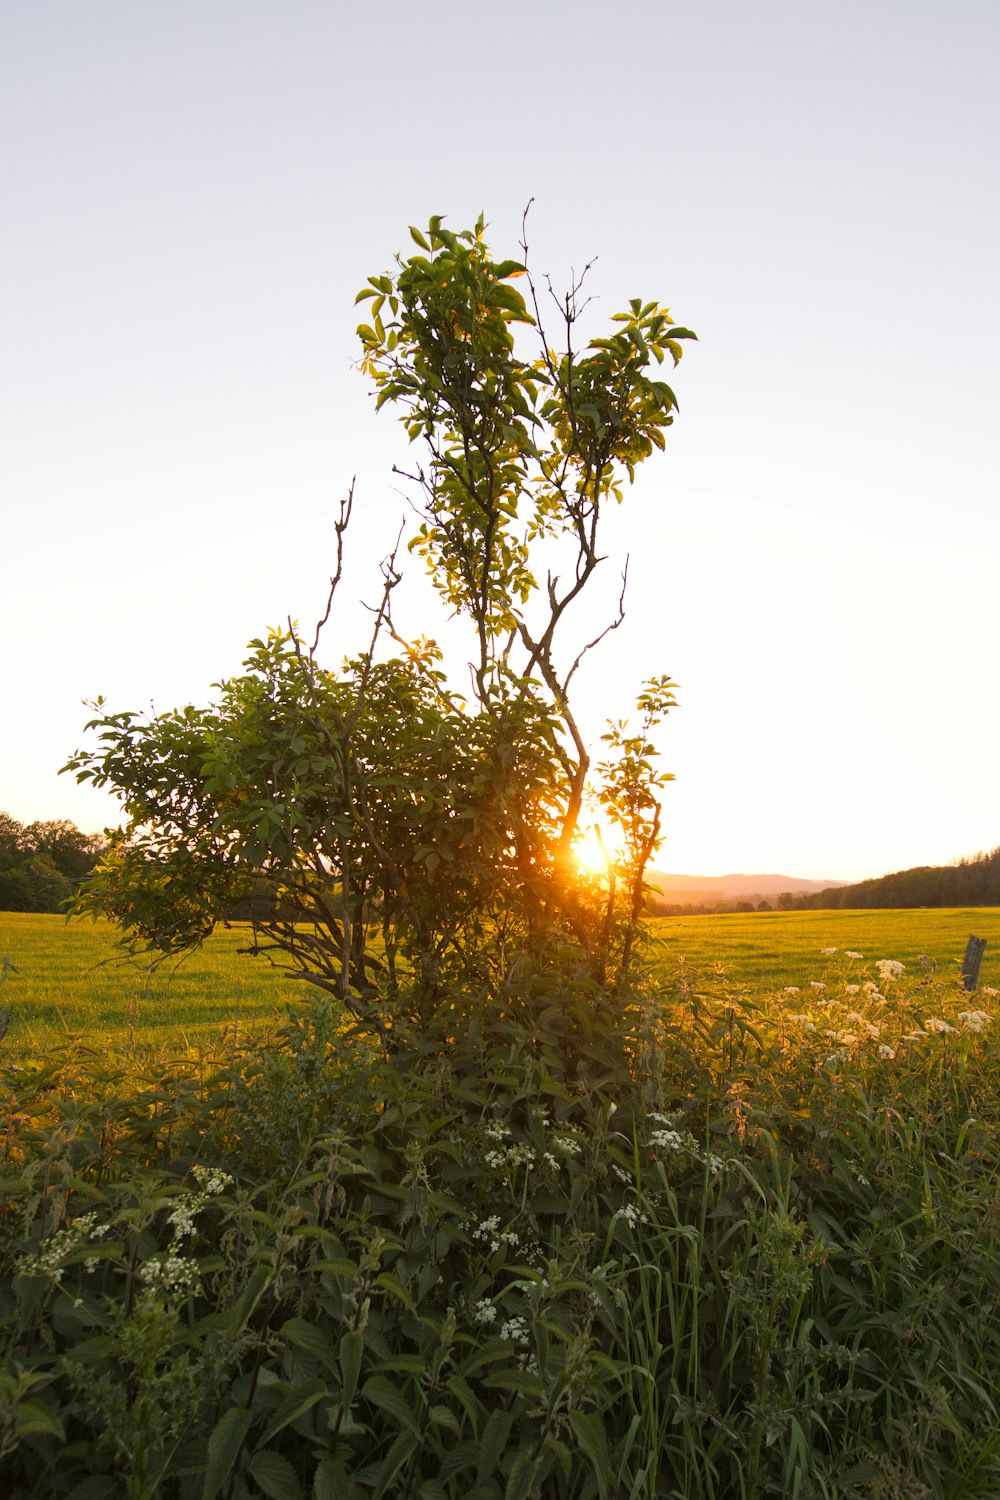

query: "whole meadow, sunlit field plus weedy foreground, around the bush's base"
(0, 911), (1000, 1500)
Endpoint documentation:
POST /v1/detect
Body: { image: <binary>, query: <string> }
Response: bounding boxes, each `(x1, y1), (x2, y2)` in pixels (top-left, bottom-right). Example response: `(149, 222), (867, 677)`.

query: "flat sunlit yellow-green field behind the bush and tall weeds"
(0, 908), (1000, 1052)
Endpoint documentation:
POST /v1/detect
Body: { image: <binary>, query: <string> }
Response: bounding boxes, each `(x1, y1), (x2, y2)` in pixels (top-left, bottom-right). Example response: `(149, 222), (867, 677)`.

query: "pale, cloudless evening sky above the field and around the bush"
(0, 0), (1000, 881)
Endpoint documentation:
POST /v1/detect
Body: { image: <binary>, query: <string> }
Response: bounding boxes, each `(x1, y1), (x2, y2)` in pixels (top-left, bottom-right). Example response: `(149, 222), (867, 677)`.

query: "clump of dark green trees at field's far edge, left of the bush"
(0, 813), (106, 912)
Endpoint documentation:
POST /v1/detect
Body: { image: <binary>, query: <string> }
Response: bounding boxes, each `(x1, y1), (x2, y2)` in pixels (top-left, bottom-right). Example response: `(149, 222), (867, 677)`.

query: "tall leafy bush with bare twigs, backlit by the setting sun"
(67, 218), (694, 1043)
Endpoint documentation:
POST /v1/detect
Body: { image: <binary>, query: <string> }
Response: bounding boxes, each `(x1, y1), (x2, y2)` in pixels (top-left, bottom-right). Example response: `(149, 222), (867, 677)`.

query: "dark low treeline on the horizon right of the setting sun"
(648, 848), (1000, 917)
